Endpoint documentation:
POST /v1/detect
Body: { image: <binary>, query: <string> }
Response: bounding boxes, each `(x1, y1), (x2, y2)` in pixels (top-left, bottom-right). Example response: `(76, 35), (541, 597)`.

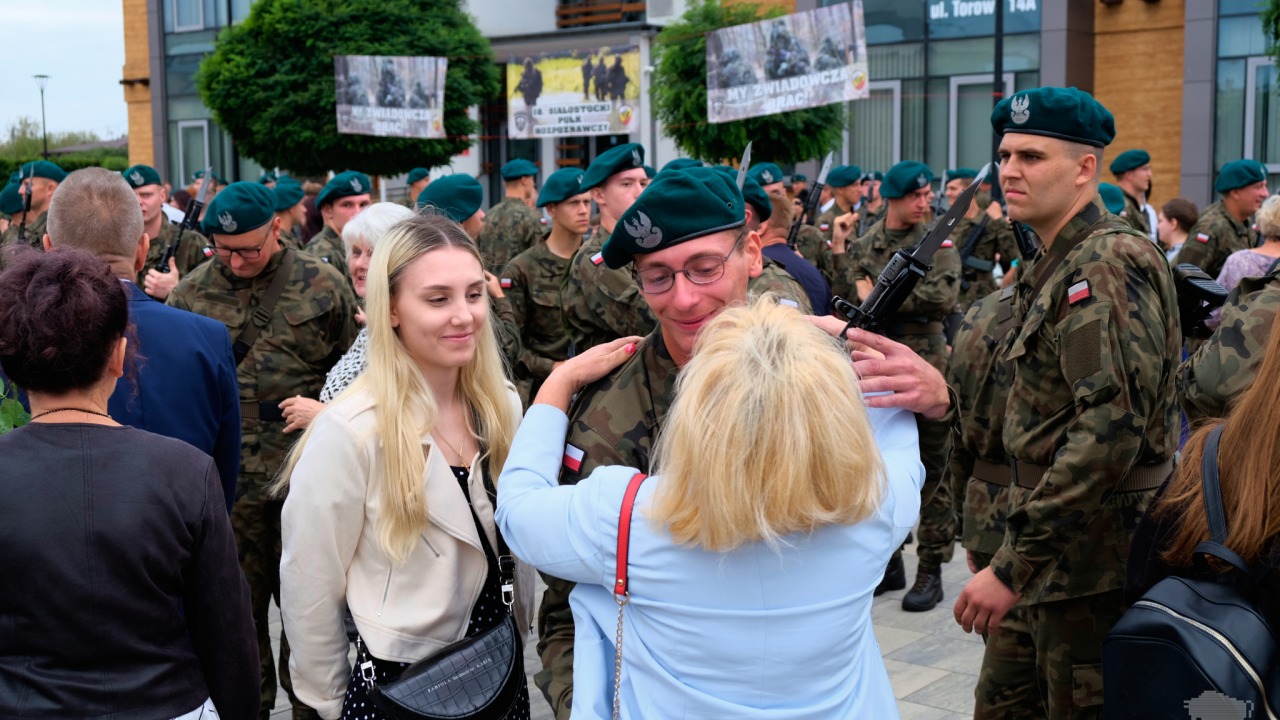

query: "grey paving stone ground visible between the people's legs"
(264, 532), (982, 720)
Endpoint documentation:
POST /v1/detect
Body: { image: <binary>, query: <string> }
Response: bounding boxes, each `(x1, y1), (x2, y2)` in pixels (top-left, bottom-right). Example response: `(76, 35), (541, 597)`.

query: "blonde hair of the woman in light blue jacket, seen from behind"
(649, 296), (884, 551)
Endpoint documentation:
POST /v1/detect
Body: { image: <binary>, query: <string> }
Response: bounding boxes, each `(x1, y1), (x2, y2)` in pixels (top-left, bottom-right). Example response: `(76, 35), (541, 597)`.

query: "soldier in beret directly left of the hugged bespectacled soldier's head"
(561, 142), (655, 354)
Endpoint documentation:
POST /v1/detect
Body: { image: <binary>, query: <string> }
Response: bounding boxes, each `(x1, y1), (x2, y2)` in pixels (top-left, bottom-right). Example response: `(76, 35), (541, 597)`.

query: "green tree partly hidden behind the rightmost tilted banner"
(653, 0), (845, 163)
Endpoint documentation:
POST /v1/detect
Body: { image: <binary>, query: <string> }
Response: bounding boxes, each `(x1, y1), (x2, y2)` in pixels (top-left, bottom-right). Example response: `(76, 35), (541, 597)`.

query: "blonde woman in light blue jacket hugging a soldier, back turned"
(494, 299), (924, 720)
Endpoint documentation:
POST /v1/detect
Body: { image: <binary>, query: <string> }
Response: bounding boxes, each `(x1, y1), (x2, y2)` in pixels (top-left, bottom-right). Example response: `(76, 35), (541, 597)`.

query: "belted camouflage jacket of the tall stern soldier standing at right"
(991, 199), (1181, 603)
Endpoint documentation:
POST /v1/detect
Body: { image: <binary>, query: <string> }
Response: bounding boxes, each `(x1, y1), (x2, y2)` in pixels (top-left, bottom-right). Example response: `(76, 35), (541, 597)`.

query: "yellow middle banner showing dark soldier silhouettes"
(507, 45), (640, 138)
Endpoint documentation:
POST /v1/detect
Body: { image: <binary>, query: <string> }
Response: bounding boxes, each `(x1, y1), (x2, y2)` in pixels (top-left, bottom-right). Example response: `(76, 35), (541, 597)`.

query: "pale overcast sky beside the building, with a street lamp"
(0, 0), (129, 140)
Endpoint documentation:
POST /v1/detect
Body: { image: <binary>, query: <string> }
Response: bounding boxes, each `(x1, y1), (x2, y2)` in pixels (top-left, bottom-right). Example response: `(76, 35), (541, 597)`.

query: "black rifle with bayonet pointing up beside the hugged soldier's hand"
(832, 163), (991, 337)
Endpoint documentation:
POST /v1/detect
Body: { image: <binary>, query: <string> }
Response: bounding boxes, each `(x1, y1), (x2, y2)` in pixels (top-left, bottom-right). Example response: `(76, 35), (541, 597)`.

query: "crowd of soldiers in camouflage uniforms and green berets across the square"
(0, 79), (1280, 719)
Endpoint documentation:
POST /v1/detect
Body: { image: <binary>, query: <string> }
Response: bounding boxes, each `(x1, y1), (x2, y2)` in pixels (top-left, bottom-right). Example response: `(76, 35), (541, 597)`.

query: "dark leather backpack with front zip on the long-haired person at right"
(1102, 425), (1280, 720)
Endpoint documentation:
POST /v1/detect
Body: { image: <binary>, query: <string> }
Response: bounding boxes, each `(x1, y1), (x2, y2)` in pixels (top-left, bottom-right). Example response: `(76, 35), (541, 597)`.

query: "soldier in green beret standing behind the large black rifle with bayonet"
(832, 161), (960, 611)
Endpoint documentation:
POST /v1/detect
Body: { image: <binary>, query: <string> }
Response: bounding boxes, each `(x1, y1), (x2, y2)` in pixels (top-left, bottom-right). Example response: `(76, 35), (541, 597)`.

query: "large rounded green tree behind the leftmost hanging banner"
(197, 0), (499, 176)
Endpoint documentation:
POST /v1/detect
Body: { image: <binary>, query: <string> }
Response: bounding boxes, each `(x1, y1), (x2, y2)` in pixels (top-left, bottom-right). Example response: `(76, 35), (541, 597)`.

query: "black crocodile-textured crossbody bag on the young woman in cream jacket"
(356, 458), (525, 720)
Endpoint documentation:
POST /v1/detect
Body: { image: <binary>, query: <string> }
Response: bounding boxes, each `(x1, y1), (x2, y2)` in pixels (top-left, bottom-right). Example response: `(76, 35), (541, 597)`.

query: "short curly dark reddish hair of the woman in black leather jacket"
(0, 247), (132, 395)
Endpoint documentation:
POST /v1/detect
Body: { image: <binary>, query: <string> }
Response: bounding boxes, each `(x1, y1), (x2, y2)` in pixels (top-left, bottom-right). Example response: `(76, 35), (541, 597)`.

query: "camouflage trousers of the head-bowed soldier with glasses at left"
(232, 484), (319, 720)
